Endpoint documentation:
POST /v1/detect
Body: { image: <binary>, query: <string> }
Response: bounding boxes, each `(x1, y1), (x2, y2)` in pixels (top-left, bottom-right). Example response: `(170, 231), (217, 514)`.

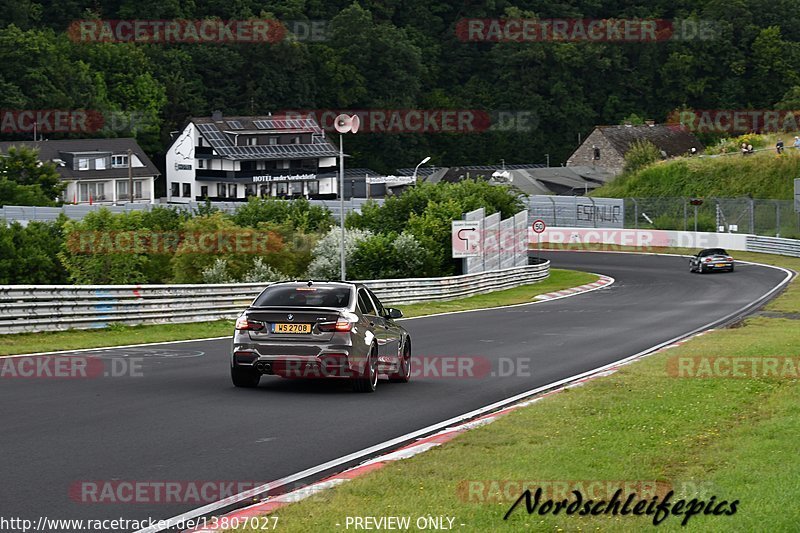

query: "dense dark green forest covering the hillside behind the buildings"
(0, 0), (800, 176)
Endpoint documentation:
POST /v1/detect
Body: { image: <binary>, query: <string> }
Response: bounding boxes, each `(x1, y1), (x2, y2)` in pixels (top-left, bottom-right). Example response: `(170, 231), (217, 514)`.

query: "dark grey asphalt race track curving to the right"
(0, 252), (785, 520)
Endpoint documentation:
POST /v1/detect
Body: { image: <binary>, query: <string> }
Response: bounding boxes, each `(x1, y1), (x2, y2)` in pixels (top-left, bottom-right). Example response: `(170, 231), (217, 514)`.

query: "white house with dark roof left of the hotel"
(0, 138), (160, 205)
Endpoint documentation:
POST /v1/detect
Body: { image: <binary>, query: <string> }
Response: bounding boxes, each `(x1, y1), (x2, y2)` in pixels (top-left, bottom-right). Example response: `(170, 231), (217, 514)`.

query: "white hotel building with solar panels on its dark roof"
(166, 112), (339, 203)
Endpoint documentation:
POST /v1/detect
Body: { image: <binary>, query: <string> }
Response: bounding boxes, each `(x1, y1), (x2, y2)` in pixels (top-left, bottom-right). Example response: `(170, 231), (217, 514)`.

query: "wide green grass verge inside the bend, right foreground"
(228, 249), (800, 532)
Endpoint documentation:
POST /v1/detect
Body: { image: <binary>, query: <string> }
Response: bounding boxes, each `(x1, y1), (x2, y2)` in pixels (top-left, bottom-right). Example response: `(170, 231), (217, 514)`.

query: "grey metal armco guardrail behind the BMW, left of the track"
(0, 262), (550, 334)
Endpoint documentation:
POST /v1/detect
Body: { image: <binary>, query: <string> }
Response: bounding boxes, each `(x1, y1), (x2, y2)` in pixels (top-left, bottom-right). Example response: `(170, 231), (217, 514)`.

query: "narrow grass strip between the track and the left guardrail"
(0, 269), (597, 356)
